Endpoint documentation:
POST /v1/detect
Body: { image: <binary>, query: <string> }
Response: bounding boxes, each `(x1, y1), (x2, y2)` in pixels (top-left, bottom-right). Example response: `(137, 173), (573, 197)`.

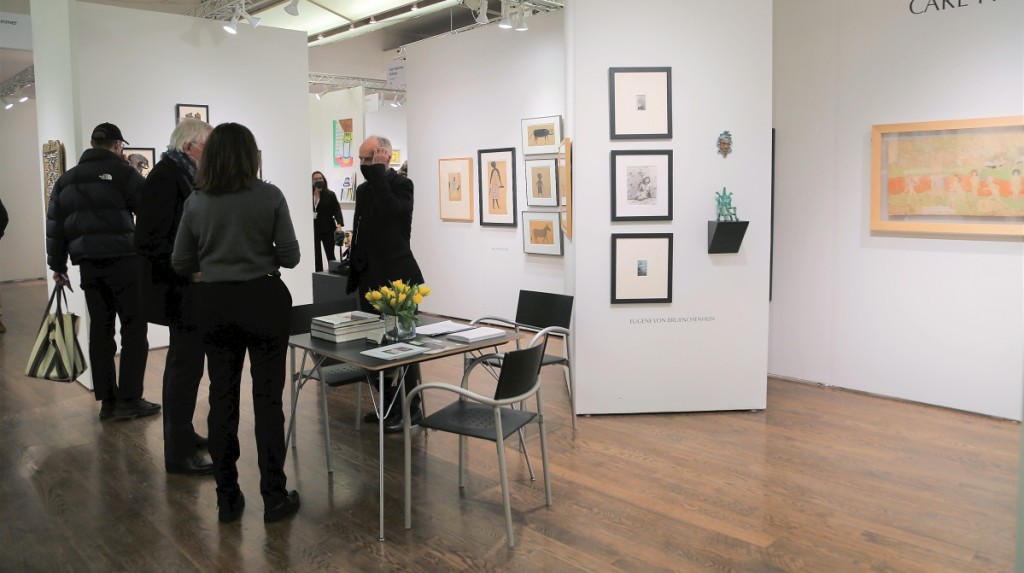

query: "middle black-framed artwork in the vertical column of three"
(611, 149), (672, 221)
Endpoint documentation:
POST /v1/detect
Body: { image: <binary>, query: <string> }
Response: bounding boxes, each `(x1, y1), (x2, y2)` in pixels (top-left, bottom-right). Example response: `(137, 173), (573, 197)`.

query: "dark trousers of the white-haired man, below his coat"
(163, 324), (206, 462)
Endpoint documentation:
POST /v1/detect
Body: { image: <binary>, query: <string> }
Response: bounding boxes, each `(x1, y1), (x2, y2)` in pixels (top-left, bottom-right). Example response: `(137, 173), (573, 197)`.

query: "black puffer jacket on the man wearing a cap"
(46, 148), (145, 272)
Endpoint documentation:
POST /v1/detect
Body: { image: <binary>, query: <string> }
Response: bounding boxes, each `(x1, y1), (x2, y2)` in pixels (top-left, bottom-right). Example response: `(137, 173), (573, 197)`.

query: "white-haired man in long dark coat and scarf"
(135, 118), (213, 476)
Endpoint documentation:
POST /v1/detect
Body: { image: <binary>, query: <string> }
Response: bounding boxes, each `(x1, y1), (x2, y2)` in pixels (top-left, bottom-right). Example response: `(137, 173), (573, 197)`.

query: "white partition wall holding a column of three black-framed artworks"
(566, 0), (772, 413)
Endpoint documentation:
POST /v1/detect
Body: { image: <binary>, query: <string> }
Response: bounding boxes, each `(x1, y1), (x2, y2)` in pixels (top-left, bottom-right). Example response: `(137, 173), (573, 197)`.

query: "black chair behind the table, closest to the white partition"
(470, 291), (577, 430)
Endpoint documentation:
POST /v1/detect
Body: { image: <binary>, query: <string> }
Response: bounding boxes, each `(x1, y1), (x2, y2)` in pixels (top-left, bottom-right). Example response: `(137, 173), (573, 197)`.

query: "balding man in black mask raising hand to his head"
(346, 135), (424, 433)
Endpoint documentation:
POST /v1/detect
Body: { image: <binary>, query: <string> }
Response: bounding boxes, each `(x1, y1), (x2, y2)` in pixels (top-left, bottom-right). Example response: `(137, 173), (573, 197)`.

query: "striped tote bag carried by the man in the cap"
(25, 284), (86, 382)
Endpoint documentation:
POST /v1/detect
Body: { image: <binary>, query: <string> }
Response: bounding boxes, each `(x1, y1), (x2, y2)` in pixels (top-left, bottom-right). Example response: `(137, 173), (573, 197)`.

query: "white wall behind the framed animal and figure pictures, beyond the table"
(405, 11), (565, 318)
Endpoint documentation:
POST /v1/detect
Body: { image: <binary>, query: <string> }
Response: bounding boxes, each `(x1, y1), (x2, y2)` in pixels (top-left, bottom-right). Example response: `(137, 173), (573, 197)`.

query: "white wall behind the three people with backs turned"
(32, 0), (312, 386)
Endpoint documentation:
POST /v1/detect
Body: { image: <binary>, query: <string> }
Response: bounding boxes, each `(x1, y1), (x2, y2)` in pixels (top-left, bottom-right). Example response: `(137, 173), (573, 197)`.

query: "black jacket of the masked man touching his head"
(347, 165), (423, 293)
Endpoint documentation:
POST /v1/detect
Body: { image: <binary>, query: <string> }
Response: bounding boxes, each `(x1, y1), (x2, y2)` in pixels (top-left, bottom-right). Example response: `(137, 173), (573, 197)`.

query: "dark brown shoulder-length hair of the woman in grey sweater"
(196, 123), (259, 194)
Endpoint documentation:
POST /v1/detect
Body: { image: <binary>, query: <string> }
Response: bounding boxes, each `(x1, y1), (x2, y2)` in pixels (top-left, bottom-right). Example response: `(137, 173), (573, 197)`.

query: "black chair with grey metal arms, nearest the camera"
(402, 334), (551, 547)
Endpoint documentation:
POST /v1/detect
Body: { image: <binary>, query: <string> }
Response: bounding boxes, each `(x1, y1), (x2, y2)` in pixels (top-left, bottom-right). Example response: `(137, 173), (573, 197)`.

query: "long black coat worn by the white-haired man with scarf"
(135, 157), (195, 326)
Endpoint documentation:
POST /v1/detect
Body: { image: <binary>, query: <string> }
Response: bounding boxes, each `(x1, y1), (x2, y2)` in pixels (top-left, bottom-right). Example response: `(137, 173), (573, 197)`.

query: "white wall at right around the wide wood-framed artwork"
(769, 0), (1024, 420)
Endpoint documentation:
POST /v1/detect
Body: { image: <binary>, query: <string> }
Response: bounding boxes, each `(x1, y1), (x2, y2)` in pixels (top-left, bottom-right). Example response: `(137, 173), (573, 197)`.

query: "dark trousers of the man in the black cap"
(79, 257), (150, 401)
